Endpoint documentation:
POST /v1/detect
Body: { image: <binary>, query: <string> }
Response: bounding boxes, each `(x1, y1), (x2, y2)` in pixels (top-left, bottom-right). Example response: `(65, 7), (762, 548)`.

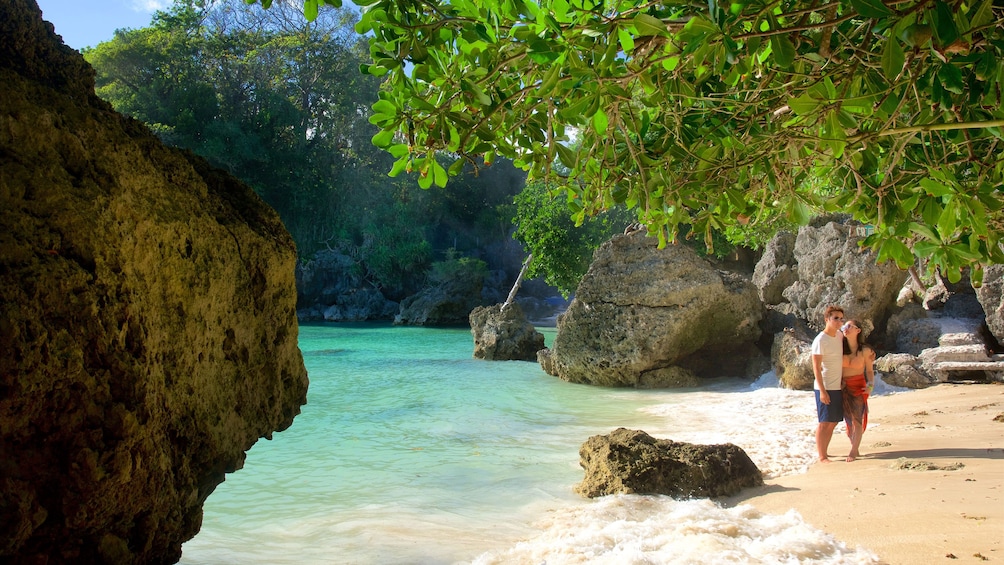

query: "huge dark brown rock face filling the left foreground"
(0, 0), (307, 563)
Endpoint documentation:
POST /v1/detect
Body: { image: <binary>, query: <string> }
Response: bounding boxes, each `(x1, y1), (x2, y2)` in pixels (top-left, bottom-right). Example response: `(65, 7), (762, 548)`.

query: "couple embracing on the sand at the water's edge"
(812, 306), (875, 463)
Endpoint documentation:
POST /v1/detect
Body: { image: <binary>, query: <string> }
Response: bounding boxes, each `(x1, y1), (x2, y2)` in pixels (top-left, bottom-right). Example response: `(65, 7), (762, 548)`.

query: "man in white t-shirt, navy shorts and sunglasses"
(812, 306), (843, 463)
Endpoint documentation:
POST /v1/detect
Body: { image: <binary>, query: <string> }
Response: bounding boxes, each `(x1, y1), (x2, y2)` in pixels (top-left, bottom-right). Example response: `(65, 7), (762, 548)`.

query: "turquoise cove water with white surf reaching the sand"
(182, 324), (869, 565)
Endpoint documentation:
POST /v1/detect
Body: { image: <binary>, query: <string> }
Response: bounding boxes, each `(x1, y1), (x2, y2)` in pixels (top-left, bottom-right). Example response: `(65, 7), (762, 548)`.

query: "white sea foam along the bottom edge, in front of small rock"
(473, 495), (879, 565)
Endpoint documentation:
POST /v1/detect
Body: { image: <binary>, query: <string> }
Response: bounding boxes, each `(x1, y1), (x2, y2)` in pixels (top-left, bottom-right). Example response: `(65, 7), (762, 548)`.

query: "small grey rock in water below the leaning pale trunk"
(470, 303), (544, 361)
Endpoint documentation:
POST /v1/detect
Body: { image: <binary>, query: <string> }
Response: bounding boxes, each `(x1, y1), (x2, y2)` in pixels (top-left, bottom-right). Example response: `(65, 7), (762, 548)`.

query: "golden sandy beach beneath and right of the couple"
(726, 383), (1004, 565)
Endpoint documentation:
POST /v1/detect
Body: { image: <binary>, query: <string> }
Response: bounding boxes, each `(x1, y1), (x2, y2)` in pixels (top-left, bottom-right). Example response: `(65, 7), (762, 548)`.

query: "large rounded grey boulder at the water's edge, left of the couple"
(541, 233), (762, 387)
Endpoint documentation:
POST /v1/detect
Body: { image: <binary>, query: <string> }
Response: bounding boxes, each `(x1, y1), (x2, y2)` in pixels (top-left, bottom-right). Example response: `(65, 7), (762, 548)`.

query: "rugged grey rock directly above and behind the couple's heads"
(754, 219), (909, 339)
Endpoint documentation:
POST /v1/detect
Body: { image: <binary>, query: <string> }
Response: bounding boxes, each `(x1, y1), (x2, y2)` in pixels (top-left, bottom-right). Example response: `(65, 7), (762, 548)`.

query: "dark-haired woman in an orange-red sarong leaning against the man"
(840, 320), (875, 462)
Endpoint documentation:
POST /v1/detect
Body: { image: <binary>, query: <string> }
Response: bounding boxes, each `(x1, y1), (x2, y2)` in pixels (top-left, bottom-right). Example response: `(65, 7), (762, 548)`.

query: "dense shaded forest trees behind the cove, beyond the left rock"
(84, 0), (550, 299)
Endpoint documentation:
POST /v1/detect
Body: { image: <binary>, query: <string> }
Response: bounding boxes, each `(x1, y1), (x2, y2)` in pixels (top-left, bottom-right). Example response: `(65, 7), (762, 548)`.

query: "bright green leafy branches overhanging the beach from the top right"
(327, 0), (1004, 283)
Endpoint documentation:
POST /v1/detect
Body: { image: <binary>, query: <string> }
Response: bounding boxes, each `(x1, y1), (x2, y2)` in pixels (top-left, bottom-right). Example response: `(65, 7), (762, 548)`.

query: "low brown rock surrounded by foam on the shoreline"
(575, 428), (763, 498)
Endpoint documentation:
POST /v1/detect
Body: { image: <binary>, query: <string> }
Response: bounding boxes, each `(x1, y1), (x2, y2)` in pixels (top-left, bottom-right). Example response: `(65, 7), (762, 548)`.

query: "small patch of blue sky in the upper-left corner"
(36, 0), (171, 50)
